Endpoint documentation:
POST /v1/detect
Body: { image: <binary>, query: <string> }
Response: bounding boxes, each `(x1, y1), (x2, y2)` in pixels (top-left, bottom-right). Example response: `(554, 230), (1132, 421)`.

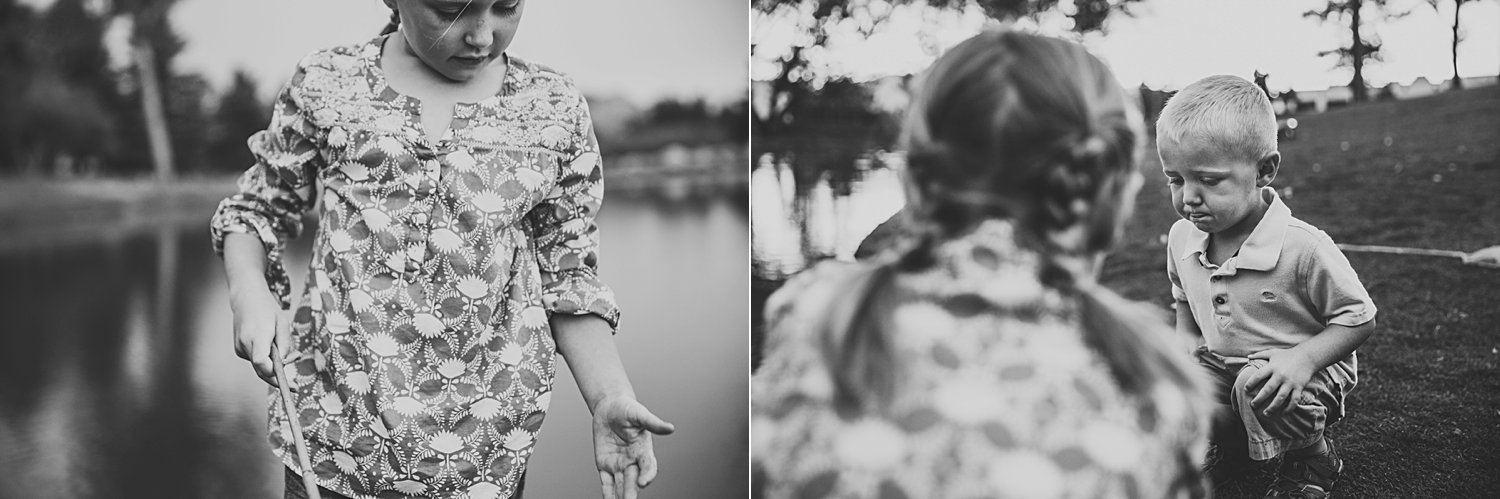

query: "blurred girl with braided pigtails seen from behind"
(752, 30), (1208, 498)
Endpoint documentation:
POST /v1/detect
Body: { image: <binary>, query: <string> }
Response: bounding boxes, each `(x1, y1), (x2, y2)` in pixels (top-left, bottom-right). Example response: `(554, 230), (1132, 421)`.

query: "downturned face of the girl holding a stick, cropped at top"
(387, 0), (525, 81)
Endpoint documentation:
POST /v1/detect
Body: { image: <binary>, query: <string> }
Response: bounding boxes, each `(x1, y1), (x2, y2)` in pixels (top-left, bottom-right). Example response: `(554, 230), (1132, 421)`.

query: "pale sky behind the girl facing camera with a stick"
(24, 0), (749, 105)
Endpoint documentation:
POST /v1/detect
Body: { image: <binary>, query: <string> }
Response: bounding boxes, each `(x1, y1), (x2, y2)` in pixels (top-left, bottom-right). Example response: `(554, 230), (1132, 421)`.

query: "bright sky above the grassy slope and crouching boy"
(752, 0), (1500, 91)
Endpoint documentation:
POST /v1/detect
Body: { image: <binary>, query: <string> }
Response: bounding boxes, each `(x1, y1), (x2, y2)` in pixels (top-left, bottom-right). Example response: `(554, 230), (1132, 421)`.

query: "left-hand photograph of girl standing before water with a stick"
(0, 0), (749, 499)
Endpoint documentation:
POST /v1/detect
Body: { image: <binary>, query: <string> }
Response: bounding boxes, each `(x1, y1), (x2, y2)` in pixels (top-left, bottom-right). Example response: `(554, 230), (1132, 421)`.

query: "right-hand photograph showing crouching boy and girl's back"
(750, 0), (1500, 498)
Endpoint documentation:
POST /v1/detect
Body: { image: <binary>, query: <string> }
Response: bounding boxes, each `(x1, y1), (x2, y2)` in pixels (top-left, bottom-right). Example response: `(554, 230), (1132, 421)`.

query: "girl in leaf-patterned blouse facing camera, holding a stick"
(213, 0), (672, 499)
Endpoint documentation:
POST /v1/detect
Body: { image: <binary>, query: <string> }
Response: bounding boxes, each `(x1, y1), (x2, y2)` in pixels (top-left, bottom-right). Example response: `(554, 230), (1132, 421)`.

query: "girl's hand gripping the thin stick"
(230, 286), (291, 387)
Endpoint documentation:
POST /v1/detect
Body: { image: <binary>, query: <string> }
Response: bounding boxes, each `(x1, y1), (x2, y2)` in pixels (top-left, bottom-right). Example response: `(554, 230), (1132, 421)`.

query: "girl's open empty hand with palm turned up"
(594, 397), (677, 499)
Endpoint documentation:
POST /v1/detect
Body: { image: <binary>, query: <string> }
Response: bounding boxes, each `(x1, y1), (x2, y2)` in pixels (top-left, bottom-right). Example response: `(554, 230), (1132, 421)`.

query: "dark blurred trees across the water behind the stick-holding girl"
(0, 0), (749, 178)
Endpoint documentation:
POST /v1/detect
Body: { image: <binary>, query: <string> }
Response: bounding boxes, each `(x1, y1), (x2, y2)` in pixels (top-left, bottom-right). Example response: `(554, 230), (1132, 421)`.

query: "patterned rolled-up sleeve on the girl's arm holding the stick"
(210, 66), (321, 307)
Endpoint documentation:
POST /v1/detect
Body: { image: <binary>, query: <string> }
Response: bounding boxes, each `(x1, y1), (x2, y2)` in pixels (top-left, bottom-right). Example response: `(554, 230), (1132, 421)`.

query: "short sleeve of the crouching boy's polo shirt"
(1299, 235), (1376, 327)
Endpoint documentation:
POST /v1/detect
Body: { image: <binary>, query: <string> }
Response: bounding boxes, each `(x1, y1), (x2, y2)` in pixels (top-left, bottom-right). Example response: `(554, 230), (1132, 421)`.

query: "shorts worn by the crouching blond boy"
(1197, 346), (1356, 460)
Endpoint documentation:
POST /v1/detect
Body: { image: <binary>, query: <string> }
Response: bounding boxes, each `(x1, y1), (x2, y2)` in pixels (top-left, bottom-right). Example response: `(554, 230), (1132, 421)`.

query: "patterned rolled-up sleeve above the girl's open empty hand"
(527, 91), (620, 328)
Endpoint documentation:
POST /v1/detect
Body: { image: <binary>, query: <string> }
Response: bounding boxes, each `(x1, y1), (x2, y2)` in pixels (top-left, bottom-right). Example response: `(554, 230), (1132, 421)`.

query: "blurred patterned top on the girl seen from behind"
(752, 220), (1208, 499)
